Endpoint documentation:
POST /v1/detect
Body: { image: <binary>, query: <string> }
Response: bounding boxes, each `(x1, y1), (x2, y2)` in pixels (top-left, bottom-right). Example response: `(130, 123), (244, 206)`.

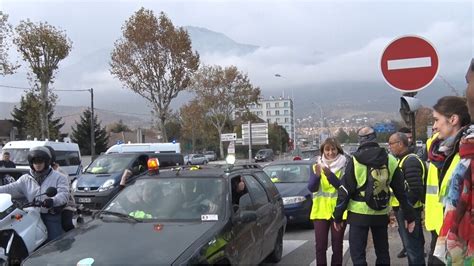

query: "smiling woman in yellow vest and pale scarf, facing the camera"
(308, 138), (347, 265)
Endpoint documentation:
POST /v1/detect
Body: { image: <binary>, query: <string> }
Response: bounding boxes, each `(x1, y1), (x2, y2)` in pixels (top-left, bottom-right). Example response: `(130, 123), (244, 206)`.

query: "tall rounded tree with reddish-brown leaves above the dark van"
(110, 8), (199, 140)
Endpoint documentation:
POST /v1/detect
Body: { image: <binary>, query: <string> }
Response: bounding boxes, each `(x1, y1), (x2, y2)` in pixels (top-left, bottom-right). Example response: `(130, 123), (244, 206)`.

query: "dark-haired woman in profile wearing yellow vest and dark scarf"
(425, 96), (470, 265)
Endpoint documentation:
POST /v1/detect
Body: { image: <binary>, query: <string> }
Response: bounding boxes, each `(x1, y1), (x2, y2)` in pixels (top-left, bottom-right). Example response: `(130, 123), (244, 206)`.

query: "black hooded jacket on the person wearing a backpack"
(334, 142), (414, 226)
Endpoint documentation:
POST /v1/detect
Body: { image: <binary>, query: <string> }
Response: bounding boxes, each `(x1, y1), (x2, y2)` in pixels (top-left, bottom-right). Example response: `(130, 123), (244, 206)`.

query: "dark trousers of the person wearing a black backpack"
(349, 224), (390, 265)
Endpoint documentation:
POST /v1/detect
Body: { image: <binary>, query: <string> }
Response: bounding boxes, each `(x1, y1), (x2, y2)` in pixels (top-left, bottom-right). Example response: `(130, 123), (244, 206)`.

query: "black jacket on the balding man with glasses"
(399, 153), (427, 205)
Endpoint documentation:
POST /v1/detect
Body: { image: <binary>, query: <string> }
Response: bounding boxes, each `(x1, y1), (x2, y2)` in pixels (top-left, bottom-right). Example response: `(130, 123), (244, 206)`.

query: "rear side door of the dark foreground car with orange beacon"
(243, 174), (274, 263)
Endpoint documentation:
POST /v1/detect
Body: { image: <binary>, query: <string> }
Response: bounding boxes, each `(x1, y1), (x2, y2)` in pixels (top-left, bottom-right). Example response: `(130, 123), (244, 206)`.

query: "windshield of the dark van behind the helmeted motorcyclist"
(86, 154), (135, 174)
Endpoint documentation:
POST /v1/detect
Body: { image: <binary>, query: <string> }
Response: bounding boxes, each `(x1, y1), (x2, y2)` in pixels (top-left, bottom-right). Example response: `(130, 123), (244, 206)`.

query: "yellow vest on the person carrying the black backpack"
(347, 154), (398, 215)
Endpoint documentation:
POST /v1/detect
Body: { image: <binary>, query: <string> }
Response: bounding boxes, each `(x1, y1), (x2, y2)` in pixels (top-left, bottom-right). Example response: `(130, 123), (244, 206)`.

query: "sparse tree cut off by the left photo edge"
(0, 11), (19, 76)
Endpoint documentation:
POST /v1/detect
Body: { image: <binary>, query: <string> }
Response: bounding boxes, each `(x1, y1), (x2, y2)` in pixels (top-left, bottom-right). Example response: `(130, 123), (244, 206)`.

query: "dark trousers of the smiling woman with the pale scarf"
(313, 220), (346, 265)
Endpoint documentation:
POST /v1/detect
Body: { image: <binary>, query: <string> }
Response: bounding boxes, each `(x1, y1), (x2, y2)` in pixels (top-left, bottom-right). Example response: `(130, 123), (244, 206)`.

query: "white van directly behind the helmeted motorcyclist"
(2, 140), (82, 180)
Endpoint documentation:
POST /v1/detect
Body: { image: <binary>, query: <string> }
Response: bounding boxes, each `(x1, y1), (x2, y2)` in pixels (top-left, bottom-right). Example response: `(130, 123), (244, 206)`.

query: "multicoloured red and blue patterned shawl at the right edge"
(435, 125), (474, 265)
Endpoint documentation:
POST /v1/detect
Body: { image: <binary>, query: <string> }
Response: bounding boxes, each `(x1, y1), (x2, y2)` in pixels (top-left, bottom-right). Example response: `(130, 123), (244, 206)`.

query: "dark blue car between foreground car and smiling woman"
(263, 160), (316, 226)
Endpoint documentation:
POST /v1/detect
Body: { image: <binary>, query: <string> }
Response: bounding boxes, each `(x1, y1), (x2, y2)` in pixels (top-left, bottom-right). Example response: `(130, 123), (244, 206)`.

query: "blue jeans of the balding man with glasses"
(396, 208), (425, 265)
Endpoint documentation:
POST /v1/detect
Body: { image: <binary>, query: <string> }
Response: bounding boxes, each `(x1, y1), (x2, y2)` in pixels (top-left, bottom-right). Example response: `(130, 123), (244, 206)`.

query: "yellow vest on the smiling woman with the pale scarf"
(310, 168), (347, 220)
